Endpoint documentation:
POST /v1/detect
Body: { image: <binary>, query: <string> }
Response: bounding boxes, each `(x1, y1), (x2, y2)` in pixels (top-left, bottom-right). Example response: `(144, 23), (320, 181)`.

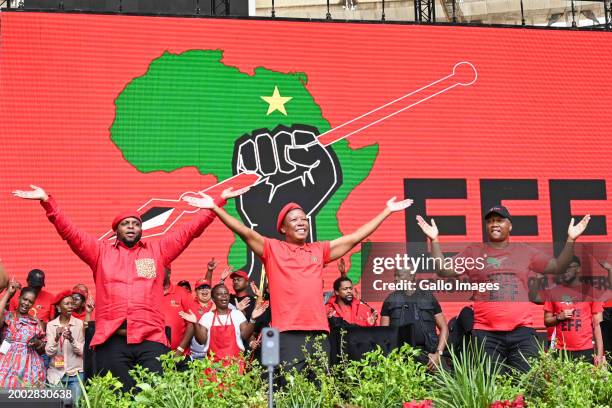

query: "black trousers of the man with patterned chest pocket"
(94, 334), (170, 392)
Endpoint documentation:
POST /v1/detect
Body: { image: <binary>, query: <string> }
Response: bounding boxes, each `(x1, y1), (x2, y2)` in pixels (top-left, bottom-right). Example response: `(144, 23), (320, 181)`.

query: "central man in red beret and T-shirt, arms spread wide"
(185, 197), (412, 370)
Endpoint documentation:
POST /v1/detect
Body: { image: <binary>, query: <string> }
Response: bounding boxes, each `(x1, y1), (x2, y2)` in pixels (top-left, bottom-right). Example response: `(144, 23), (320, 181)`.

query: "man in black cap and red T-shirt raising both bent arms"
(417, 205), (590, 372)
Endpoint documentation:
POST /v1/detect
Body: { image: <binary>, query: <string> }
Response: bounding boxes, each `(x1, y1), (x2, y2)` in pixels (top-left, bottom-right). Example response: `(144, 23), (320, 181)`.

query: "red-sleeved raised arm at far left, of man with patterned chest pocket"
(13, 185), (100, 269)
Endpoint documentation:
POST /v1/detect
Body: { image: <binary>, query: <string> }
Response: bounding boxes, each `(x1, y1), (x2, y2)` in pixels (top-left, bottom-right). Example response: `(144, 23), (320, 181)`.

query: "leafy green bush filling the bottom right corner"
(521, 352), (612, 408)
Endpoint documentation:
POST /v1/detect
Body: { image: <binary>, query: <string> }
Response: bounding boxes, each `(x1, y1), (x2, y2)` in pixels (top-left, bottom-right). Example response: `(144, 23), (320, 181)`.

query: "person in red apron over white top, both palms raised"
(179, 284), (268, 372)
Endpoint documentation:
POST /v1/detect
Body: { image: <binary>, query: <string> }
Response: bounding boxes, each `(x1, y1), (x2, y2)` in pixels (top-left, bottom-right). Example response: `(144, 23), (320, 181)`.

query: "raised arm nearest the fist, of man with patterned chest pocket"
(159, 187), (249, 265)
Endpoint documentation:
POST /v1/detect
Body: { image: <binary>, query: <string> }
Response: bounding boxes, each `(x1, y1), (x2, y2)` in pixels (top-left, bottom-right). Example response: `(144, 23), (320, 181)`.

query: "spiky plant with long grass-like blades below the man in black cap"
(433, 342), (522, 408)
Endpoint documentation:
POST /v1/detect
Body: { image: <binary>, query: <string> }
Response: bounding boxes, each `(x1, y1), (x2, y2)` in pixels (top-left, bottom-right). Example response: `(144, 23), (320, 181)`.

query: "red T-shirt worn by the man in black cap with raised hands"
(455, 243), (551, 331)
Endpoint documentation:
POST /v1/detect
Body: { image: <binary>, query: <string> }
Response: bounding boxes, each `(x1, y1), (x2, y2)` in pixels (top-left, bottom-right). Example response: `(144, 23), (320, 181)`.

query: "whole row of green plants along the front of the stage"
(80, 345), (612, 408)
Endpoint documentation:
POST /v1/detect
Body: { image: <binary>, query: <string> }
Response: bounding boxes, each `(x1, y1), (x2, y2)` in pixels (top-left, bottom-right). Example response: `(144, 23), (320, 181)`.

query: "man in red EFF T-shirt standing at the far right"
(544, 256), (605, 365)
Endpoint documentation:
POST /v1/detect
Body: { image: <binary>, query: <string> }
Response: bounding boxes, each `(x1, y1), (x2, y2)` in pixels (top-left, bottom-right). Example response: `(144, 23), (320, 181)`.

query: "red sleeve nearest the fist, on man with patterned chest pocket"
(159, 198), (225, 265)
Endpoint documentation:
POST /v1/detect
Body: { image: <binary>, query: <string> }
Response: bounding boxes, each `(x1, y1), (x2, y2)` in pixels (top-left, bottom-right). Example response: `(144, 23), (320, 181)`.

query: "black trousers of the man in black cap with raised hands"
(472, 327), (539, 373)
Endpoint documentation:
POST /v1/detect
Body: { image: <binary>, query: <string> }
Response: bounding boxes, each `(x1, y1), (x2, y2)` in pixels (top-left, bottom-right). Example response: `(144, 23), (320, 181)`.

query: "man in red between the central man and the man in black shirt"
(326, 276), (378, 327)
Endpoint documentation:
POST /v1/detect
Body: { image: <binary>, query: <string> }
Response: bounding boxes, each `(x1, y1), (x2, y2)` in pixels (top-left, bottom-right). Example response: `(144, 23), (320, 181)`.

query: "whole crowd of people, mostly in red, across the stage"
(0, 186), (612, 404)
